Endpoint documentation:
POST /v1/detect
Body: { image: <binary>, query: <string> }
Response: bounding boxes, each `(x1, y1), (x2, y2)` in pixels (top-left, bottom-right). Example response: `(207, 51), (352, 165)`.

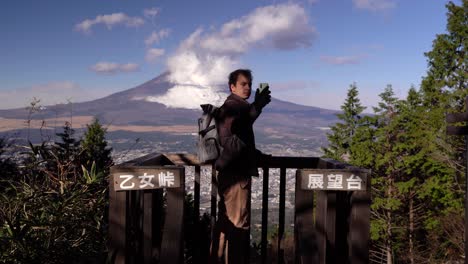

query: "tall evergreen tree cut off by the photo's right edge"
(421, 0), (468, 202)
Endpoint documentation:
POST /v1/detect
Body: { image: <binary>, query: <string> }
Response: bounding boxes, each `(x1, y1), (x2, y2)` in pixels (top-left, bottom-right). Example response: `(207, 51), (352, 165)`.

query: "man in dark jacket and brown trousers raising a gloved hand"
(211, 69), (271, 264)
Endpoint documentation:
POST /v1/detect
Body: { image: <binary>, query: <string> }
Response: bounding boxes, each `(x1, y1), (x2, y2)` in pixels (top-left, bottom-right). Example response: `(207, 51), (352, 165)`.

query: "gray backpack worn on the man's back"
(197, 104), (222, 164)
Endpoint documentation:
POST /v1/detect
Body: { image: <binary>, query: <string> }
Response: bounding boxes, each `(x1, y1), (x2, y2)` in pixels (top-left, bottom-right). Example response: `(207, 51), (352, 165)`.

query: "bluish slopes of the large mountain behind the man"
(0, 73), (337, 136)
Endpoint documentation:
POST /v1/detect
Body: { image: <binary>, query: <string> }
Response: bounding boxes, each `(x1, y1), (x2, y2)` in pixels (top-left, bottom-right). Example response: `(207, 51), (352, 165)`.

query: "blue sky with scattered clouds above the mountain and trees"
(0, 0), (459, 109)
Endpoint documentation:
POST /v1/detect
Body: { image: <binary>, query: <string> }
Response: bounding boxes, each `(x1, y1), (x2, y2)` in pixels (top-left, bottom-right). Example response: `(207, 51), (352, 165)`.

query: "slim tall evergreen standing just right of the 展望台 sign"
(371, 85), (402, 264)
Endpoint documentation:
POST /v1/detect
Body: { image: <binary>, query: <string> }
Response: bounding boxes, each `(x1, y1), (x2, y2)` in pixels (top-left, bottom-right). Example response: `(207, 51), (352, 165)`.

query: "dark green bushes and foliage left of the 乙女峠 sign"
(0, 120), (112, 263)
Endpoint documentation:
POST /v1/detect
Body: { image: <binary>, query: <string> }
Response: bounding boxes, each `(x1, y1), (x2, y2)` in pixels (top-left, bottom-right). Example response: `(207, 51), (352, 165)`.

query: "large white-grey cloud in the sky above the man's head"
(199, 4), (316, 54)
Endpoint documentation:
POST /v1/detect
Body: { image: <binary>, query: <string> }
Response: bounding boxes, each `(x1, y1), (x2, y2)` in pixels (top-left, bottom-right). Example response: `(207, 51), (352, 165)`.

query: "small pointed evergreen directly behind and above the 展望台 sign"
(322, 83), (366, 161)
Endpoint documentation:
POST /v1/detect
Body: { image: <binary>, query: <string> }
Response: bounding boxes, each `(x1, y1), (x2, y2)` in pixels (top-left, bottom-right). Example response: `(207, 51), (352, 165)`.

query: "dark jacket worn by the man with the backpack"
(215, 94), (261, 176)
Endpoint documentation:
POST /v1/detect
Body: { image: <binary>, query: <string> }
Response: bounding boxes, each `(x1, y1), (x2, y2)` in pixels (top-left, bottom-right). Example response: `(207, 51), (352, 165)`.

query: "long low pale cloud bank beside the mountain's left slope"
(0, 81), (112, 109)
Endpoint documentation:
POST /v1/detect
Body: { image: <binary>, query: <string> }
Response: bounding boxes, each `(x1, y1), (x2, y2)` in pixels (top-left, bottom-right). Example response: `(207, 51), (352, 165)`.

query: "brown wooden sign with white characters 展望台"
(298, 169), (369, 191)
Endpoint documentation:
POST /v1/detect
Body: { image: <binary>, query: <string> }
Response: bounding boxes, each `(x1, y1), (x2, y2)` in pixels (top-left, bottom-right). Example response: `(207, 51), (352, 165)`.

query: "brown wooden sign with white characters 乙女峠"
(111, 166), (185, 191)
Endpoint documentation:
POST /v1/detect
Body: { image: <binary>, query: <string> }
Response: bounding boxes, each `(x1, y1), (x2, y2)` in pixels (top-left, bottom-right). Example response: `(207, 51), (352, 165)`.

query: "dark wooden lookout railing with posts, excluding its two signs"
(109, 153), (370, 263)
